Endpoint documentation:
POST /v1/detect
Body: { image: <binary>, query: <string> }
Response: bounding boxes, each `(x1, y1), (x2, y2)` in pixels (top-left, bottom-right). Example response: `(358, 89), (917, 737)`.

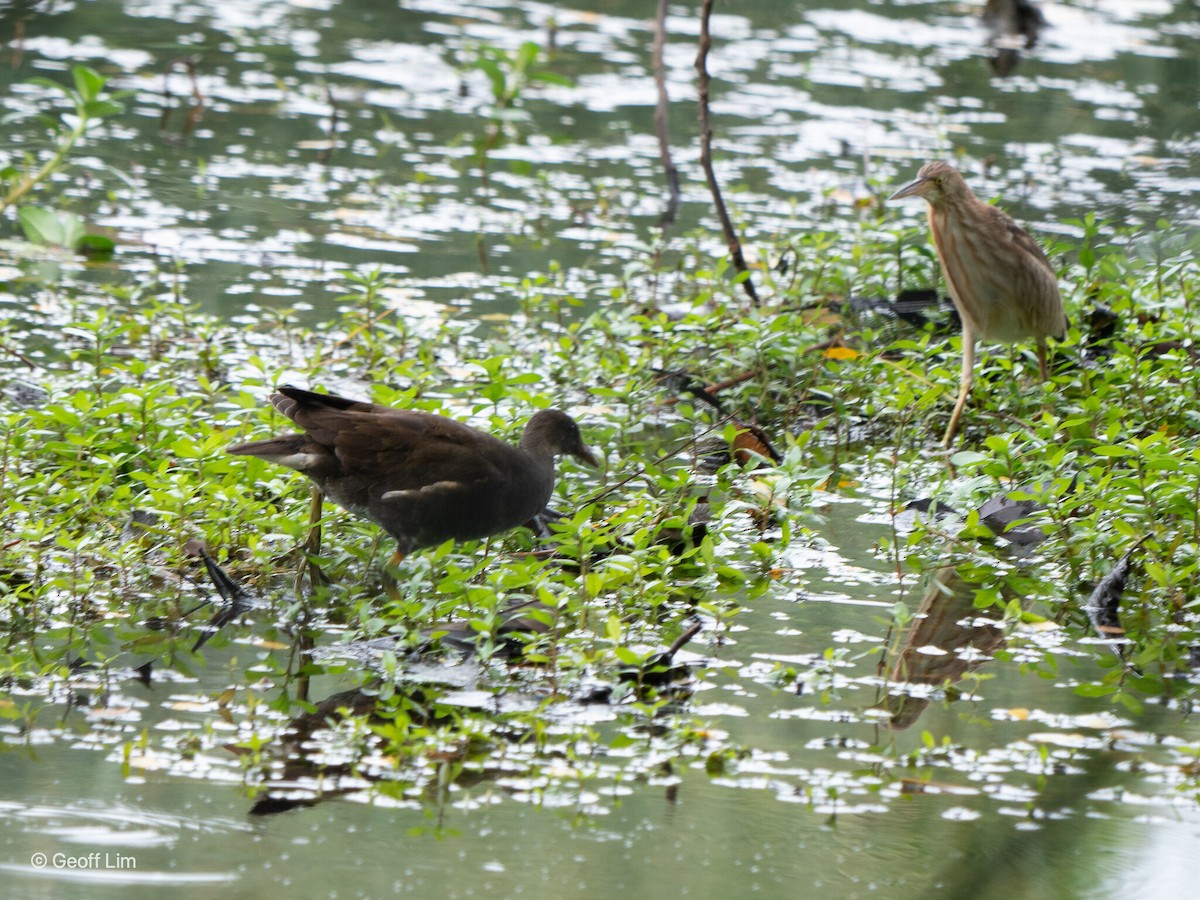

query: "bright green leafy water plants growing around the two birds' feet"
(0, 217), (1200, 810)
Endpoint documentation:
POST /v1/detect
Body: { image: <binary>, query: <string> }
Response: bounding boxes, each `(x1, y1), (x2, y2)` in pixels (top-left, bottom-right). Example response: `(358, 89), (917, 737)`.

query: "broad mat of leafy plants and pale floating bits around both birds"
(0, 213), (1200, 812)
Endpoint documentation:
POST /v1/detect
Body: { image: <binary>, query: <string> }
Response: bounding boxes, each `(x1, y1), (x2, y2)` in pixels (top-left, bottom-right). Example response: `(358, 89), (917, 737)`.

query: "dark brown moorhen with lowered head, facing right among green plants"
(227, 385), (596, 563)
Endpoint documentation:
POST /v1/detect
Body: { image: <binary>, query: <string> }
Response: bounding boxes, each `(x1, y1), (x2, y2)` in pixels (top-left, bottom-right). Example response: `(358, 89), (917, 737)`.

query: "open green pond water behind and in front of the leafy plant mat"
(0, 0), (1200, 898)
